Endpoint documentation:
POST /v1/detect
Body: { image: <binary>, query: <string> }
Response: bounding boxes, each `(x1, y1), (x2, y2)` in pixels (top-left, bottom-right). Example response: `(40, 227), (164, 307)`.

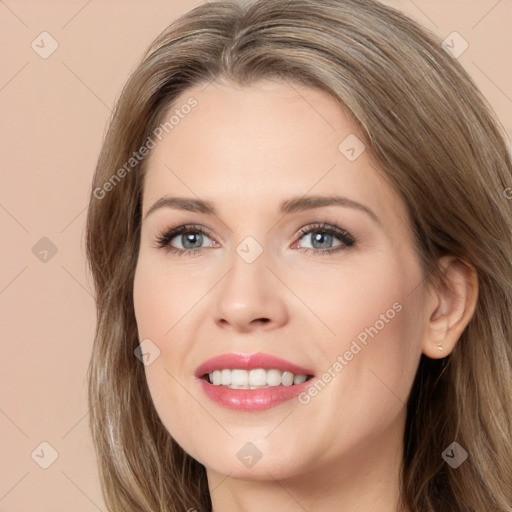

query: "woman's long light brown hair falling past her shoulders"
(87, 0), (512, 512)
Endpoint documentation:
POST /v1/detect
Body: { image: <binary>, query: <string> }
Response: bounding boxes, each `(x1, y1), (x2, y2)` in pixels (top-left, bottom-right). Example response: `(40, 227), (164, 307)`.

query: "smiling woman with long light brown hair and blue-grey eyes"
(87, 0), (512, 512)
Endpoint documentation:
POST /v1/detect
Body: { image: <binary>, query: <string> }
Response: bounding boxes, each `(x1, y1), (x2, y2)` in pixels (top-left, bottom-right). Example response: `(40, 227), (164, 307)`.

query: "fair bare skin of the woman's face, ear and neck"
(134, 80), (477, 512)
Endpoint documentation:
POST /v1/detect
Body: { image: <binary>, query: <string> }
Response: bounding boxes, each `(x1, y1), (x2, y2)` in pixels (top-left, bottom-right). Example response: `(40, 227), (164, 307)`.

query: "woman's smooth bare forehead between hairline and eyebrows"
(143, 80), (406, 230)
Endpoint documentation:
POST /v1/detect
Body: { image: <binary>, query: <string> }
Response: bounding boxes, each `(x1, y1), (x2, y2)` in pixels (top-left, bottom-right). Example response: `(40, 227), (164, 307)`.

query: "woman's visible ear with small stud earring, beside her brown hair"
(422, 255), (478, 359)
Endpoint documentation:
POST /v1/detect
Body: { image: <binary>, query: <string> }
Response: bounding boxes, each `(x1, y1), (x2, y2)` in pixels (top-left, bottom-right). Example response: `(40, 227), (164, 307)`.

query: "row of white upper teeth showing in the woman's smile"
(208, 368), (307, 389)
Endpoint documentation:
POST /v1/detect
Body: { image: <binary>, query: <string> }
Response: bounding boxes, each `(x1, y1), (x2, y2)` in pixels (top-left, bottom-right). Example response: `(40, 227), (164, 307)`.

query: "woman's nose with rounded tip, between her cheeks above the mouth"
(214, 247), (288, 333)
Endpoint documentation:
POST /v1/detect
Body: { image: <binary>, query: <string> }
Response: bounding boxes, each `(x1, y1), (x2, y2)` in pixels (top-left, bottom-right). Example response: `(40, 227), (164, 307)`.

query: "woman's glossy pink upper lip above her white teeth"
(194, 352), (313, 377)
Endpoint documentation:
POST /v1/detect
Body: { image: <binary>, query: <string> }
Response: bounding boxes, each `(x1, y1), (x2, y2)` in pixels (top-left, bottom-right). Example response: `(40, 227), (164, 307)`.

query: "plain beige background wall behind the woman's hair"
(0, 0), (512, 512)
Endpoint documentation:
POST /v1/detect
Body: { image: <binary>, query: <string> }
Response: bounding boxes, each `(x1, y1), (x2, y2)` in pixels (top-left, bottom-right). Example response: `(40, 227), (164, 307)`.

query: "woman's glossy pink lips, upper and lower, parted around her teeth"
(195, 353), (314, 412)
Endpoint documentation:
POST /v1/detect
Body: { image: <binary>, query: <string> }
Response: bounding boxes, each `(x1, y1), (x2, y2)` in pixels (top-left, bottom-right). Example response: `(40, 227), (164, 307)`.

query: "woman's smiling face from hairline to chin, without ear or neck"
(134, 80), (428, 479)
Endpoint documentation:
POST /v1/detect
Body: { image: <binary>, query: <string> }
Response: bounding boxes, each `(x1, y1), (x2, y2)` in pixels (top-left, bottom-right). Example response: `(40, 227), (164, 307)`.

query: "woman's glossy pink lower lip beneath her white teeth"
(199, 378), (314, 412)
